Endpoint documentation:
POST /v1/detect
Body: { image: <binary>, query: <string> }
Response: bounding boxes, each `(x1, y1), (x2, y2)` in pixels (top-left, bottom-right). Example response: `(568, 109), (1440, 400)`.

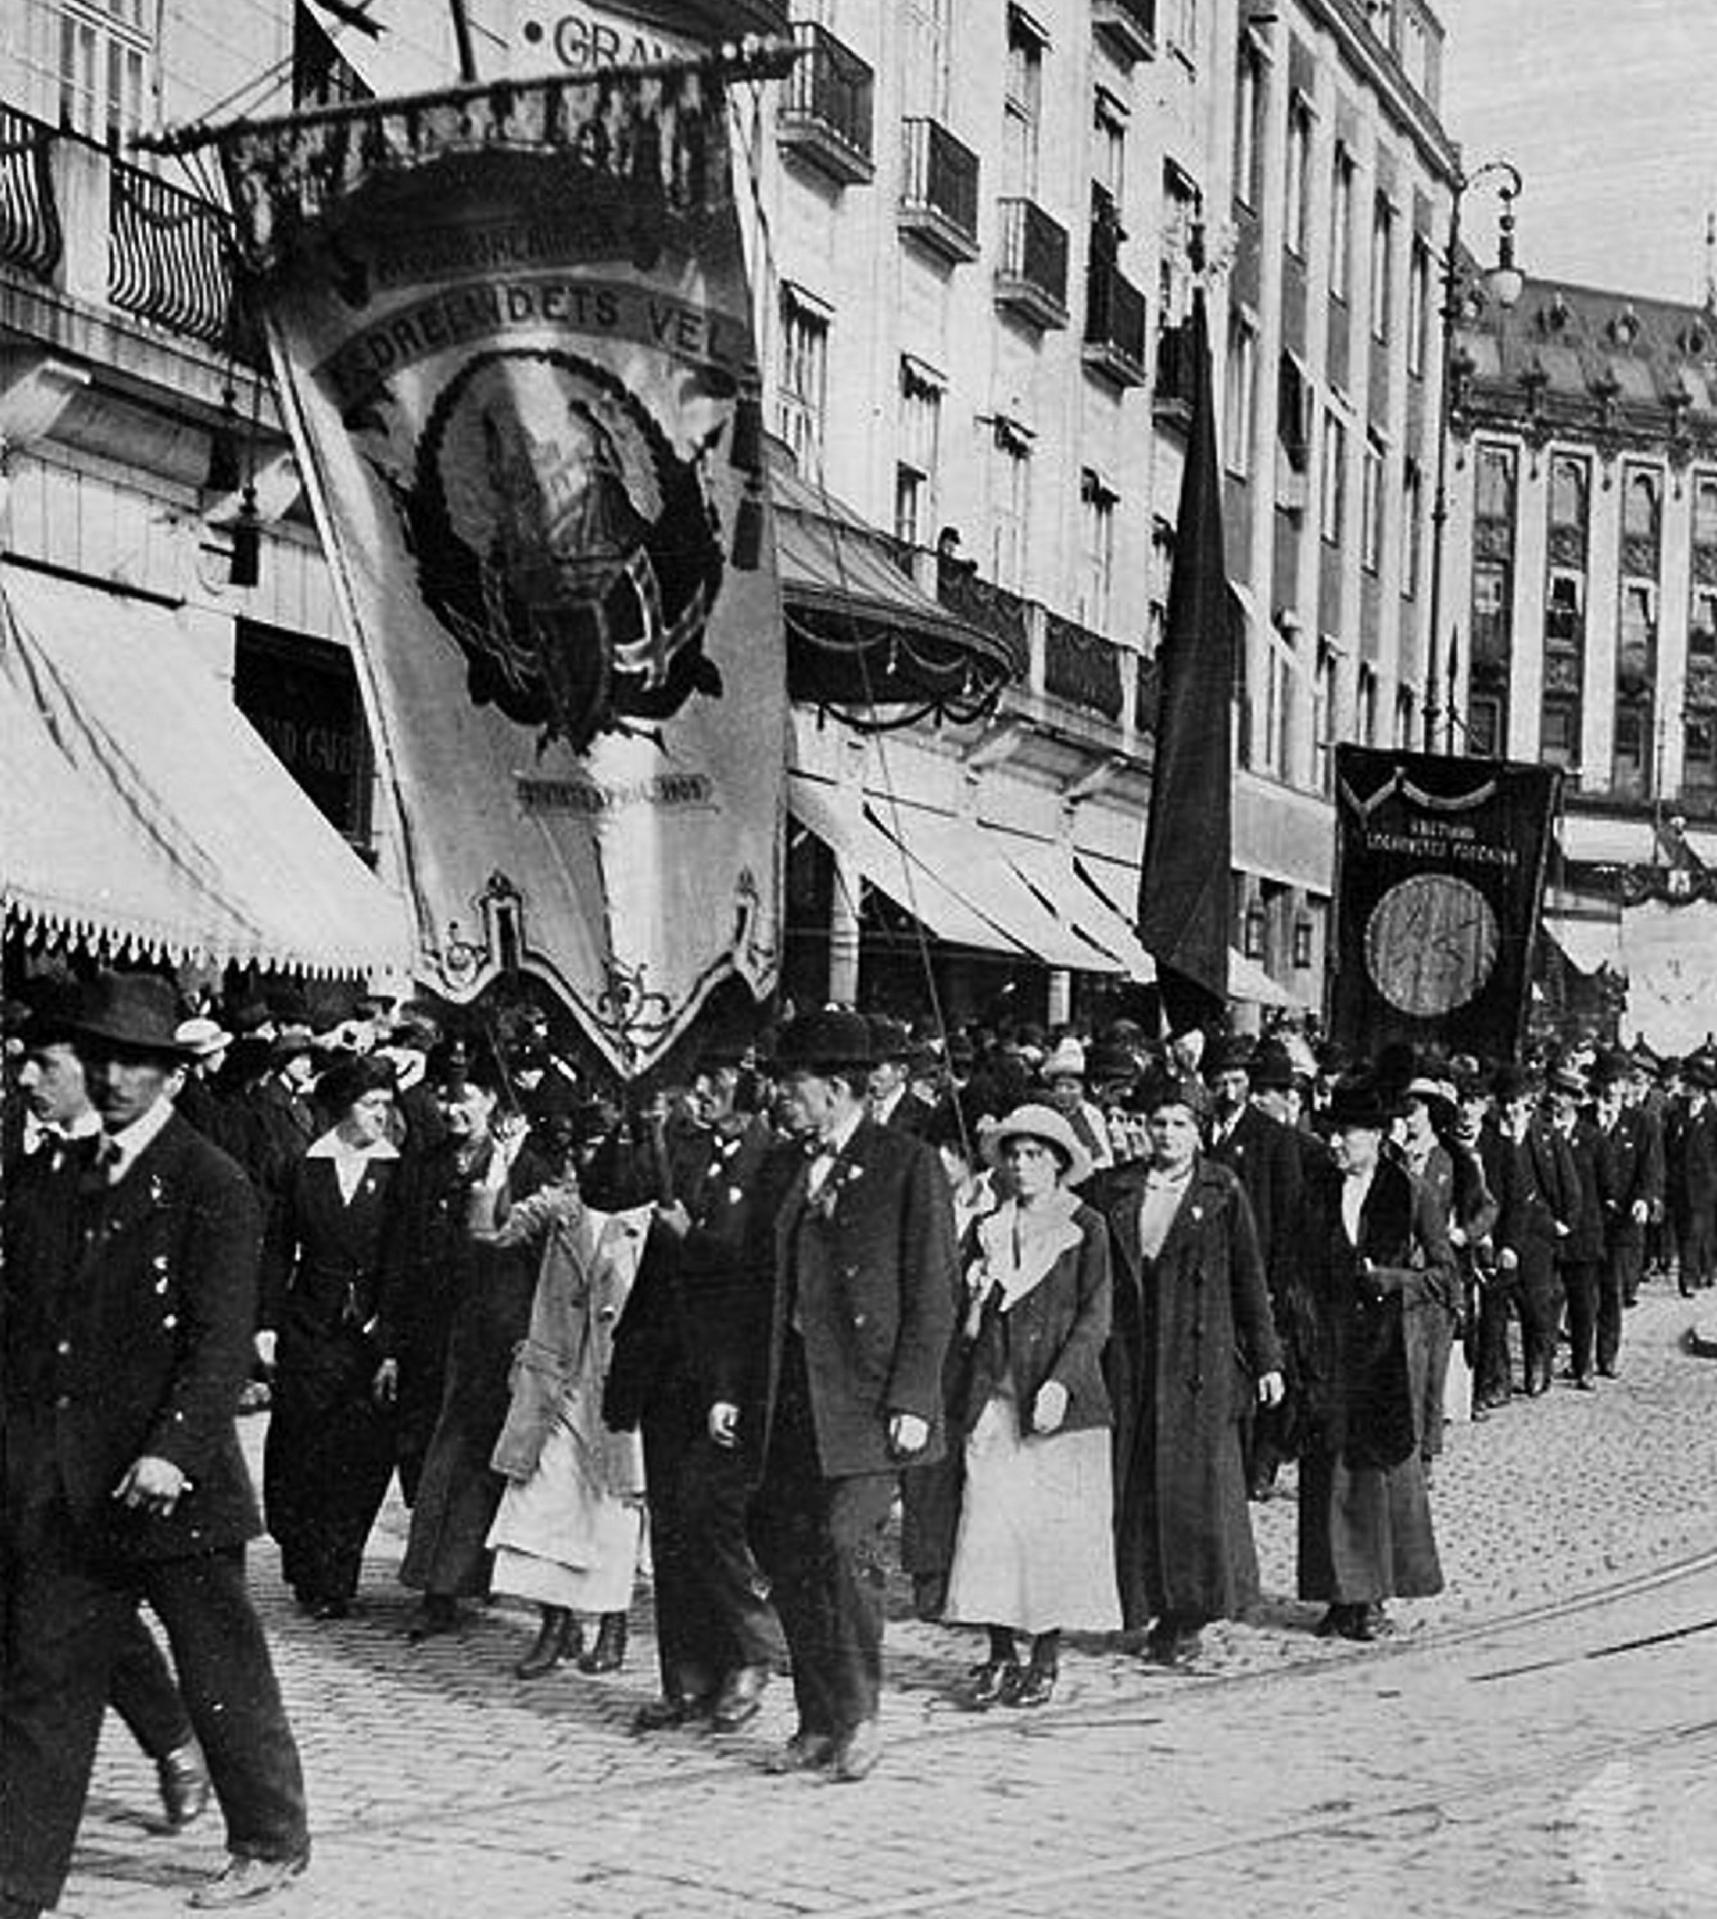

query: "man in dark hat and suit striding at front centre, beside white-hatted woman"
(712, 1013), (955, 1779)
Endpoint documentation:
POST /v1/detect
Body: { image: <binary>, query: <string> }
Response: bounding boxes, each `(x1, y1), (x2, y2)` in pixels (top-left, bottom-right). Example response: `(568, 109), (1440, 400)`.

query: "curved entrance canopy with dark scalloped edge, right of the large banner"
(769, 459), (1028, 708)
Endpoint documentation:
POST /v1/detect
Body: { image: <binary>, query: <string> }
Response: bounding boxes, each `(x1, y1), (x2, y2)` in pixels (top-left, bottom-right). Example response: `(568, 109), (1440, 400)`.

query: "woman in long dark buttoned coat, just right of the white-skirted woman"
(1092, 1075), (1282, 1666)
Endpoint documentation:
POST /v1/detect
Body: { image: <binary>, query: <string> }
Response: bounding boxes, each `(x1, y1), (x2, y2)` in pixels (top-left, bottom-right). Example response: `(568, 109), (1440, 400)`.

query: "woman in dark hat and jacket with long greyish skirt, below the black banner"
(1299, 1080), (1456, 1639)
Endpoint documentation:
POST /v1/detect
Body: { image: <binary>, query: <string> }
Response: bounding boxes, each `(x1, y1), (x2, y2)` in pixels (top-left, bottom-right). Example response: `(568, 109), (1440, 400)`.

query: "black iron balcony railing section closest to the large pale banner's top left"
(107, 159), (234, 347)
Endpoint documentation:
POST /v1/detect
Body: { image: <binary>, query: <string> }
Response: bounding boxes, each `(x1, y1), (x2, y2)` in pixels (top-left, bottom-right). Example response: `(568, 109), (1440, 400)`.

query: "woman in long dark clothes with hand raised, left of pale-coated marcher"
(382, 1046), (547, 1639)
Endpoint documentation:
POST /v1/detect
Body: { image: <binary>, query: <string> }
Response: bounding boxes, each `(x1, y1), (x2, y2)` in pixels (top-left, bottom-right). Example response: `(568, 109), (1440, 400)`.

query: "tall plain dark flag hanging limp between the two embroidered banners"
(1140, 290), (1237, 1032)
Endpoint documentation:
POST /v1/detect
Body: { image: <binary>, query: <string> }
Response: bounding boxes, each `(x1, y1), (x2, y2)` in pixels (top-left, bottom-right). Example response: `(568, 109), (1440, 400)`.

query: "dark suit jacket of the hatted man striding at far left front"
(0, 1115), (261, 1558)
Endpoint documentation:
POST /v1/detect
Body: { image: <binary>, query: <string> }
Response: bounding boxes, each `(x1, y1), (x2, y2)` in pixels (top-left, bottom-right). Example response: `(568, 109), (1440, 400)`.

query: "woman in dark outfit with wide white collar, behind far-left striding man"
(261, 1059), (399, 1620)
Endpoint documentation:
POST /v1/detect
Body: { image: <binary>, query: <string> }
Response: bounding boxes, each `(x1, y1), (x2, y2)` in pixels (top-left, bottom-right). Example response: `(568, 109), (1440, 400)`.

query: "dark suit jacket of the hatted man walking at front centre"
(764, 1119), (955, 1480)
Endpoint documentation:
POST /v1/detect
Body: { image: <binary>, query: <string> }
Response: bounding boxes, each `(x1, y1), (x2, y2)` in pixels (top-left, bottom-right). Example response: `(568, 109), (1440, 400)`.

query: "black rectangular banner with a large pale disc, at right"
(1329, 746), (1562, 1059)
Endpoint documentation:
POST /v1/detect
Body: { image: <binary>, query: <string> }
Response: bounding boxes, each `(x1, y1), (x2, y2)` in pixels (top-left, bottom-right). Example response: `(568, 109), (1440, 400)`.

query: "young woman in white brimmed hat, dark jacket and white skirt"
(946, 1105), (1120, 1710)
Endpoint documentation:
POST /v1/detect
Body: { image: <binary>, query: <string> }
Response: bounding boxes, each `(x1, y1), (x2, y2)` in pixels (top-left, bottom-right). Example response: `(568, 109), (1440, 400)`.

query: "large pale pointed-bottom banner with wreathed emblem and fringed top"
(221, 63), (787, 1077)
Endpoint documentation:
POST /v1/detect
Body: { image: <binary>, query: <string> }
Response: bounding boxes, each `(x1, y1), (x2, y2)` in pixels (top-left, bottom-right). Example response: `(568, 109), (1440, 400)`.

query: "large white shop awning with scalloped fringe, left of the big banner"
(0, 566), (411, 975)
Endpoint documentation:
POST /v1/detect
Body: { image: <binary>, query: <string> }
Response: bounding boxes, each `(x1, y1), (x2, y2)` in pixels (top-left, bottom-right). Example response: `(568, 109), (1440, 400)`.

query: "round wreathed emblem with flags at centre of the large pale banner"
(405, 349), (723, 752)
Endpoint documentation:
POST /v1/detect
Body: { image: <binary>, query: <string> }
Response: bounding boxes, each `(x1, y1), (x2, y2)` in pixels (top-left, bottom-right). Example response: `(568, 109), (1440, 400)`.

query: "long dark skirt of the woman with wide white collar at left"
(263, 1324), (393, 1604)
